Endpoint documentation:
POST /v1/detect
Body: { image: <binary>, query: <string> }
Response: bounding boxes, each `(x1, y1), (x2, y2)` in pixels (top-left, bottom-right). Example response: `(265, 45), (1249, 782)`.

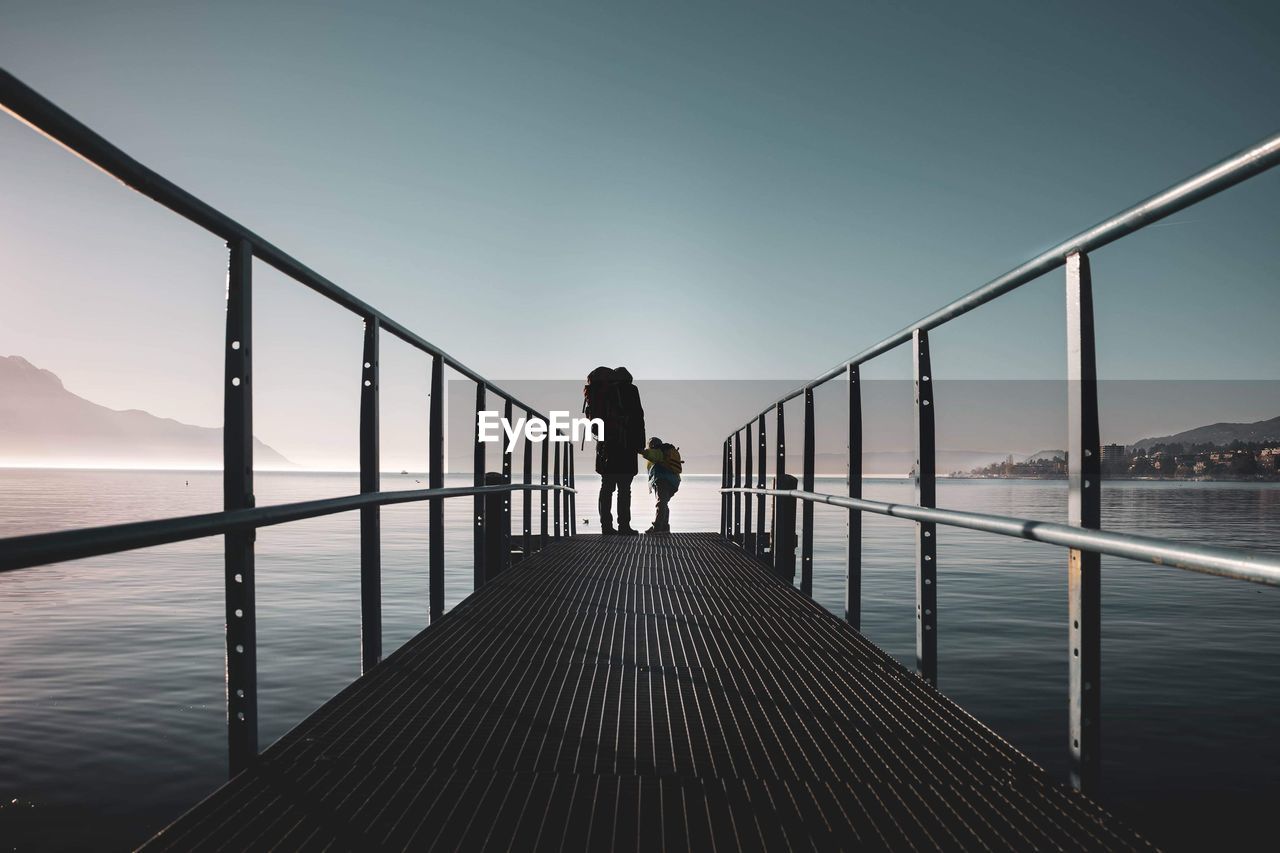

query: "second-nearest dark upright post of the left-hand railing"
(360, 316), (383, 672)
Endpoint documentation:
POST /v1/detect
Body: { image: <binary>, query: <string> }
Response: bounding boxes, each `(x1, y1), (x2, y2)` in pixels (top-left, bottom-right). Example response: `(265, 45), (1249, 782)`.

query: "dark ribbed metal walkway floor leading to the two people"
(146, 534), (1146, 850)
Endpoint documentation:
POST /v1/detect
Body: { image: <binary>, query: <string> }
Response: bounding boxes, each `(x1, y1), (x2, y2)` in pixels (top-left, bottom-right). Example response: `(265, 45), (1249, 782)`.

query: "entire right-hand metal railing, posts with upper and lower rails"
(721, 134), (1280, 790)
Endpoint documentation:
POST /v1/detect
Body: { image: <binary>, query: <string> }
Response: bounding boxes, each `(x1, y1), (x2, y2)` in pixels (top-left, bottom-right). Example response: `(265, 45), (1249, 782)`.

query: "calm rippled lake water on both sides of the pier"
(0, 470), (1280, 849)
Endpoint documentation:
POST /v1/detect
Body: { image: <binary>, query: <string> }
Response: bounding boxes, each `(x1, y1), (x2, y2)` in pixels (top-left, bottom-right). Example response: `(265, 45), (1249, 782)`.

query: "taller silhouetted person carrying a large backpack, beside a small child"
(582, 368), (645, 537)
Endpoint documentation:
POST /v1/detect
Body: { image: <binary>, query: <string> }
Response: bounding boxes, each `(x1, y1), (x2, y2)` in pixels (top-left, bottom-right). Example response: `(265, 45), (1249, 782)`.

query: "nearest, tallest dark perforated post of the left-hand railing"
(223, 240), (257, 776)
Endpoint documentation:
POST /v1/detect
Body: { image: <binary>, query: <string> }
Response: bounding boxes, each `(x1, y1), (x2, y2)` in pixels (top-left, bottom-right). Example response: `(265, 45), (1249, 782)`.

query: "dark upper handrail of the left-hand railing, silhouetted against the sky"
(0, 68), (544, 418)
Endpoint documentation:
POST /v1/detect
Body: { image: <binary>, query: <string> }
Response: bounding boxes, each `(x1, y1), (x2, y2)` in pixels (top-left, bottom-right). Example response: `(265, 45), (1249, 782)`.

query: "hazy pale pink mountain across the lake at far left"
(0, 356), (293, 467)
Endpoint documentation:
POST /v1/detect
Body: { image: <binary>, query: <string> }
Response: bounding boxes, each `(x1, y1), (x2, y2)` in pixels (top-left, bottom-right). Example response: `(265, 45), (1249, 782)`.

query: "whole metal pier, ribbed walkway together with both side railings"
(0, 72), (1280, 850)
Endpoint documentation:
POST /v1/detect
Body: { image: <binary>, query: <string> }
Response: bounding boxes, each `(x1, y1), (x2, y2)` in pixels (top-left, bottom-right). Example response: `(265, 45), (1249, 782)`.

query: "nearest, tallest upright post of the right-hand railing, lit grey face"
(1066, 252), (1102, 794)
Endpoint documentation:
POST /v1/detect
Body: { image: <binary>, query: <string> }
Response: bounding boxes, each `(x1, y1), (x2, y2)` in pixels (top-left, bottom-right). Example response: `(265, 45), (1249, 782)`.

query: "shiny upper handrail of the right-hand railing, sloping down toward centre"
(735, 126), (1280, 432)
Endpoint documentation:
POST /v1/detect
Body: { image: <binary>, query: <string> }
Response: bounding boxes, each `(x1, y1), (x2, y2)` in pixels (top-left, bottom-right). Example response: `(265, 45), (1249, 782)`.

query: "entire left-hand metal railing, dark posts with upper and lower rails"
(0, 69), (576, 776)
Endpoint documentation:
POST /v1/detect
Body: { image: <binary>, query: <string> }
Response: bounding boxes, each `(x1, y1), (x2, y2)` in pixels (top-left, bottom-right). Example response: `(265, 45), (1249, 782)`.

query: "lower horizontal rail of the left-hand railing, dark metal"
(0, 483), (576, 573)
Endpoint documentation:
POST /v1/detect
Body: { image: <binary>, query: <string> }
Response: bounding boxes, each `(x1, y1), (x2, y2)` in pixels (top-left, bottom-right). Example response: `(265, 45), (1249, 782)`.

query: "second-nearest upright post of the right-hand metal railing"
(911, 329), (938, 686)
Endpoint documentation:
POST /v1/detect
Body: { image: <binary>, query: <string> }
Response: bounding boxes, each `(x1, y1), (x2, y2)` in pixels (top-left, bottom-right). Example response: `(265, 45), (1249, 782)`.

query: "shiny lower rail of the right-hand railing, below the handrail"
(724, 488), (1280, 587)
